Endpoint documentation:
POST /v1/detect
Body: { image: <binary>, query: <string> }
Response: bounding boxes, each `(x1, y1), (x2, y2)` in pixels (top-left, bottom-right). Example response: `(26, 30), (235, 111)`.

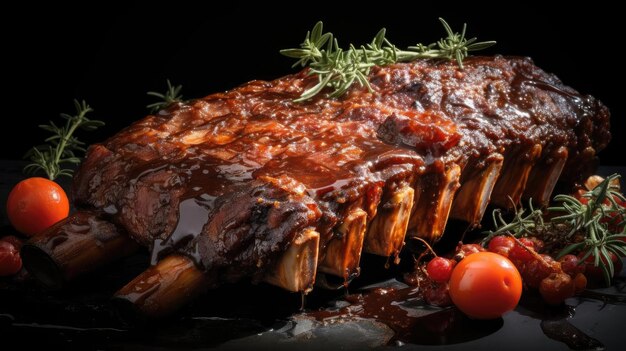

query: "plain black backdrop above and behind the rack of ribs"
(0, 1), (625, 165)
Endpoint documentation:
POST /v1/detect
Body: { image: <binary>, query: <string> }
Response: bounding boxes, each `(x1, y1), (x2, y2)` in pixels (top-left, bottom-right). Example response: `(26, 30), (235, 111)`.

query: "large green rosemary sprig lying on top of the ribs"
(280, 18), (496, 101)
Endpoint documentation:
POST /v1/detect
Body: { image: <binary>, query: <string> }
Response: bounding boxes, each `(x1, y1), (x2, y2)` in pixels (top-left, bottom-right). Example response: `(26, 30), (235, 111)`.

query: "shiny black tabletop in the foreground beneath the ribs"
(0, 162), (626, 350)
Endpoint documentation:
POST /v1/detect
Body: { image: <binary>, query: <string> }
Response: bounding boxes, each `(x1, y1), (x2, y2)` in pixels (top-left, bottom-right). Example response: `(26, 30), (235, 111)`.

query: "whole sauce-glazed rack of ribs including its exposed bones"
(24, 56), (610, 315)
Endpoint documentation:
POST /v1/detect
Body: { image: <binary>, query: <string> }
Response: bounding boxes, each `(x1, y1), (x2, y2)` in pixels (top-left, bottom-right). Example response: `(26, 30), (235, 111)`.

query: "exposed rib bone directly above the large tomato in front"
(450, 154), (502, 226)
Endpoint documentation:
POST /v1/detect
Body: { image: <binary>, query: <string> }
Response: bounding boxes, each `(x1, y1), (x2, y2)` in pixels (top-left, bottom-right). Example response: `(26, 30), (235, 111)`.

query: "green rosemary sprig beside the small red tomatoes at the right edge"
(482, 174), (626, 284)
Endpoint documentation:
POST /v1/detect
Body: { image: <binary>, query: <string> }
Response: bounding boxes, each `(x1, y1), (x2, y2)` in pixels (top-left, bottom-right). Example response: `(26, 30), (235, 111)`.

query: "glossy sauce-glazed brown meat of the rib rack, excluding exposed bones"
(74, 56), (610, 280)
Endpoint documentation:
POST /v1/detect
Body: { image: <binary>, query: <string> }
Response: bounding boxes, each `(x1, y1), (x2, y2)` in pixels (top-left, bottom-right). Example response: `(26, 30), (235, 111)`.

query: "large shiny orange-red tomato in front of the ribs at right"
(450, 252), (522, 319)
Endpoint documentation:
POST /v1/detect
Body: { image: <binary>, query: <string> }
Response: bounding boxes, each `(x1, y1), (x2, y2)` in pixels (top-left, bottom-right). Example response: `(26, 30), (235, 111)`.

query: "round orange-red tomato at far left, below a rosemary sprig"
(7, 177), (70, 236)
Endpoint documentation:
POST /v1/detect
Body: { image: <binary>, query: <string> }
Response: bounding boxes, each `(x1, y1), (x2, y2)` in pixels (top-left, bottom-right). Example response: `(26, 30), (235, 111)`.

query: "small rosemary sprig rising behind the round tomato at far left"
(24, 100), (104, 180)
